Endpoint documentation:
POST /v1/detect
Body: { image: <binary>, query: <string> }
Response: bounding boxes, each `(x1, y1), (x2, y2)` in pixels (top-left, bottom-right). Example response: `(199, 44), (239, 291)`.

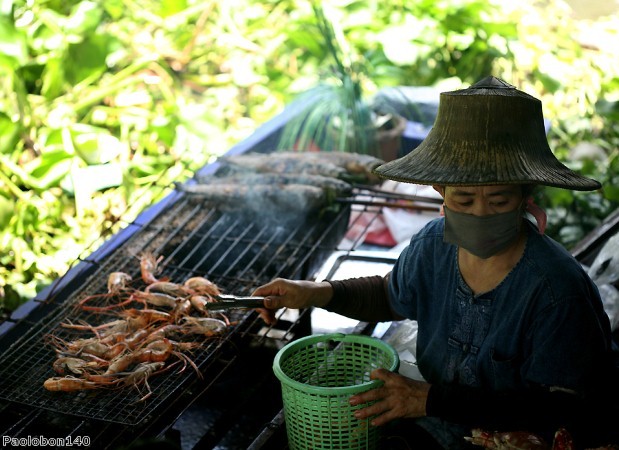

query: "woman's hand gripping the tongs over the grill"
(252, 278), (333, 325)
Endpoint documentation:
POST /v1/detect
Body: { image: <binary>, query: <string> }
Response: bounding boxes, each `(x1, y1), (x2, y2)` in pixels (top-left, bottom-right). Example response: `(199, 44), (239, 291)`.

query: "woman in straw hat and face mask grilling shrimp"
(254, 77), (610, 449)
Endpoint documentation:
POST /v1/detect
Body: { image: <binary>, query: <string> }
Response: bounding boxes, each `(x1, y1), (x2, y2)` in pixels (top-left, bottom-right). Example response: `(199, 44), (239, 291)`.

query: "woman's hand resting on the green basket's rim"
(350, 369), (430, 426)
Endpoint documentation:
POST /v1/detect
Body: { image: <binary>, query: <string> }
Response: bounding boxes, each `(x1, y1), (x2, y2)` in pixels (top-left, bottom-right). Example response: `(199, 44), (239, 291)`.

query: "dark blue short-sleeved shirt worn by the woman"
(389, 218), (610, 448)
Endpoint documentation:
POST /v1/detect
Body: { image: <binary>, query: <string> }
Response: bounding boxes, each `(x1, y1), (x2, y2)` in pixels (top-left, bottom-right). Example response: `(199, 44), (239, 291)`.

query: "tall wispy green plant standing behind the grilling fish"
(279, 5), (406, 160)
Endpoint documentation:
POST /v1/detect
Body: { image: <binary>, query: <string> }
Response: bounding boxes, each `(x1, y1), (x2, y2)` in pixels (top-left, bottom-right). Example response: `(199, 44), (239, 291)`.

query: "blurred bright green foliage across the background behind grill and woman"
(0, 0), (619, 315)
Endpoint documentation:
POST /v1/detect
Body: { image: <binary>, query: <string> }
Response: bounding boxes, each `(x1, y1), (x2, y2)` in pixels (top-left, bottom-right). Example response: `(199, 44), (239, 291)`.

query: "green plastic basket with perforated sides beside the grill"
(273, 334), (400, 450)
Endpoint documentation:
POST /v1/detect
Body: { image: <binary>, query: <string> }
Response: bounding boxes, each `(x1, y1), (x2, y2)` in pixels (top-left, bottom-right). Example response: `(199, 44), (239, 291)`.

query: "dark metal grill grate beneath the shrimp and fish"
(0, 197), (350, 425)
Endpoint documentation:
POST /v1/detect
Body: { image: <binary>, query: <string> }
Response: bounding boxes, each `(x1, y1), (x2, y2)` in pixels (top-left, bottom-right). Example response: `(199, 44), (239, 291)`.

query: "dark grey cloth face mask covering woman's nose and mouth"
(443, 206), (522, 259)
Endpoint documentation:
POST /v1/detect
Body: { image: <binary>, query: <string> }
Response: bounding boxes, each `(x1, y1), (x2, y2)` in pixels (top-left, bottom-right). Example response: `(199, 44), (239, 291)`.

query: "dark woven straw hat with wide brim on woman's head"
(374, 77), (601, 191)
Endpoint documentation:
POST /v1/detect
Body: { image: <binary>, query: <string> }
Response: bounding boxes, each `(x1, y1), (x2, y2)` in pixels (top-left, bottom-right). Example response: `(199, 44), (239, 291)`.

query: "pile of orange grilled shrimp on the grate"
(43, 254), (230, 401)
